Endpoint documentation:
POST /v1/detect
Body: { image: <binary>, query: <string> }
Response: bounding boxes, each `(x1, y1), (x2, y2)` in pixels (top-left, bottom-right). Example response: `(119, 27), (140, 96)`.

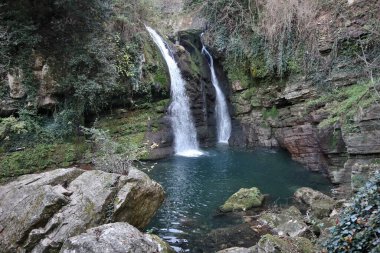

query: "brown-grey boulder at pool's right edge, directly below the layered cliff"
(294, 187), (336, 219)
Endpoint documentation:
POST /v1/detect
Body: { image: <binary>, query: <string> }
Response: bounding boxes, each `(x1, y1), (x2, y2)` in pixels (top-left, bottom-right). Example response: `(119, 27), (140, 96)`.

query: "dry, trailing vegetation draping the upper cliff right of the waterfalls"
(193, 0), (380, 91)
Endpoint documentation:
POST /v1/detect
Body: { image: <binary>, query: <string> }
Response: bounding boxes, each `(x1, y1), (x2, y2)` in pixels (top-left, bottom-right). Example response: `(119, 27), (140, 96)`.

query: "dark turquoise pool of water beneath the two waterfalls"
(147, 146), (330, 252)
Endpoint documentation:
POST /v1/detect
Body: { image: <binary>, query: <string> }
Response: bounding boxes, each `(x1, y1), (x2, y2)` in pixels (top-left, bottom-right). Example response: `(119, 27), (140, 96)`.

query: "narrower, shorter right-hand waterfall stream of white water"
(202, 46), (231, 143)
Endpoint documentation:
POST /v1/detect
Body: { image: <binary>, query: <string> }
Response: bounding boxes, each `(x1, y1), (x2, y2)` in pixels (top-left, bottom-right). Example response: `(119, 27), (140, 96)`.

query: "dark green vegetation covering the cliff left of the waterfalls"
(0, 0), (169, 181)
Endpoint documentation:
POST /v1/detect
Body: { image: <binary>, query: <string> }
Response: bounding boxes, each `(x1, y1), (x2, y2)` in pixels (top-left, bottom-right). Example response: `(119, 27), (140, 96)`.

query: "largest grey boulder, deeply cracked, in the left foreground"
(0, 168), (164, 252)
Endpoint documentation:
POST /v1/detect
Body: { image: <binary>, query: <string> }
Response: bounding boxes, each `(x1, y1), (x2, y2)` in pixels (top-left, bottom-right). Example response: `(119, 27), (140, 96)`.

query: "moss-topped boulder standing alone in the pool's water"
(219, 187), (264, 212)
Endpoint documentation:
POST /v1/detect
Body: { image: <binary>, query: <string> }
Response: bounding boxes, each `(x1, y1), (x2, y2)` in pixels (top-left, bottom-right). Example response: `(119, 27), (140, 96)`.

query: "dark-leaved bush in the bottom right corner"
(324, 171), (380, 253)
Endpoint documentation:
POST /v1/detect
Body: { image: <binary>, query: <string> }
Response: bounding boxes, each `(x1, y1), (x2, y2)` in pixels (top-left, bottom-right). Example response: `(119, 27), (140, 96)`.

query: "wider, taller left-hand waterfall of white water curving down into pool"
(146, 26), (203, 157)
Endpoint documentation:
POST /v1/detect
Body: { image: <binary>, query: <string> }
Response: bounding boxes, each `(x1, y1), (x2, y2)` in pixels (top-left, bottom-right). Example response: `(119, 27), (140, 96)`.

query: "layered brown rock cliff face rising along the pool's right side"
(232, 1), (380, 198)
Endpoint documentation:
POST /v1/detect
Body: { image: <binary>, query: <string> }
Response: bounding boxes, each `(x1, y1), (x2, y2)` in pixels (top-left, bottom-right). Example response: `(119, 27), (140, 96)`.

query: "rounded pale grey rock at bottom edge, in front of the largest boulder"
(60, 222), (174, 253)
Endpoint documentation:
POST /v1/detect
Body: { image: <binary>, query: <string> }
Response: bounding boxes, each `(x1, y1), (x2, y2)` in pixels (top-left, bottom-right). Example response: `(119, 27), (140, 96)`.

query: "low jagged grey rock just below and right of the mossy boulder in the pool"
(258, 206), (310, 237)
